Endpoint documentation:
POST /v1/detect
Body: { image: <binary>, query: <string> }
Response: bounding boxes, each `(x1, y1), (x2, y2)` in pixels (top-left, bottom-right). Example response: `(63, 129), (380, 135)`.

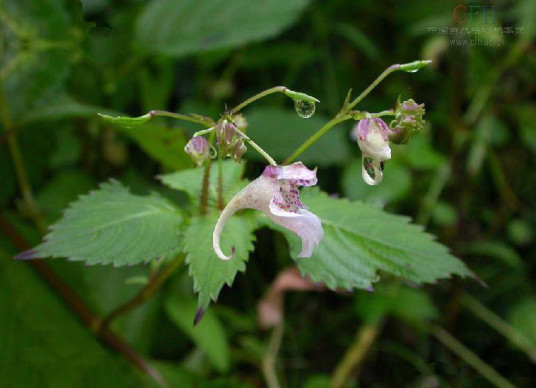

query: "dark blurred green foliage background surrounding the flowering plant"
(0, 0), (536, 387)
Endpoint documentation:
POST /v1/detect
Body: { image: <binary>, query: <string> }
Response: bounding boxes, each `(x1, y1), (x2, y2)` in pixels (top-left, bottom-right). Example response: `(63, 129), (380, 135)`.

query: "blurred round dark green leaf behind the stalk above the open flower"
(245, 108), (357, 166)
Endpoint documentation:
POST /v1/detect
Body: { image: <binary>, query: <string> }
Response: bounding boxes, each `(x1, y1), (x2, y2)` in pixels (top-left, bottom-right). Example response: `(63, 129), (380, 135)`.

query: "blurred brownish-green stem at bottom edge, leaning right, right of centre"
(330, 320), (383, 388)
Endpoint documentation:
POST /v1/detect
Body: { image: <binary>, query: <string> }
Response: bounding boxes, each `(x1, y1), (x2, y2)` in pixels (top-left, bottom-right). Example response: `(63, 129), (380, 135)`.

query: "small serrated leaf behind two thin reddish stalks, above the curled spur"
(159, 160), (246, 203)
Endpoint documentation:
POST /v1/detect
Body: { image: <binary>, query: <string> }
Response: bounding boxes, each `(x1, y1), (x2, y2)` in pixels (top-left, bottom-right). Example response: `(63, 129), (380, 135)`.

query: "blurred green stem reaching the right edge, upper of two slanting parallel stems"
(462, 294), (536, 363)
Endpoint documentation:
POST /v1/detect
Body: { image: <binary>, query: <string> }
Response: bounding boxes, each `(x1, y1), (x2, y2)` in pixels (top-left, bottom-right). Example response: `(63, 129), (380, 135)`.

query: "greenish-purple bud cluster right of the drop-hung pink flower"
(389, 99), (425, 144)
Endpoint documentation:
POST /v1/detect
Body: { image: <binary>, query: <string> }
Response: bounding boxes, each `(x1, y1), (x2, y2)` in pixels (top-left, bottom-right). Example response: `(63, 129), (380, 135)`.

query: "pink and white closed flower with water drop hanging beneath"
(352, 117), (391, 185)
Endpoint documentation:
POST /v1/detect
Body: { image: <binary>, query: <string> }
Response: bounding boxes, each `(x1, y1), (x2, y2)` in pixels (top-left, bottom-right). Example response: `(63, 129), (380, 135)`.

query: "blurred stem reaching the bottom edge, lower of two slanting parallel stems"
(426, 324), (515, 388)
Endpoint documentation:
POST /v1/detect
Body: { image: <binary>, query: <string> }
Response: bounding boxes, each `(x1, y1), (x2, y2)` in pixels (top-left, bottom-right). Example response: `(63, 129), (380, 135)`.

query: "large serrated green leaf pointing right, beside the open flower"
(287, 190), (472, 289)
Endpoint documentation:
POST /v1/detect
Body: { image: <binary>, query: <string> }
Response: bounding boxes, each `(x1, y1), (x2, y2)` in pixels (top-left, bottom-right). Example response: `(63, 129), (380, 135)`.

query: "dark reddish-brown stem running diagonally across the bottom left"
(0, 215), (168, 387)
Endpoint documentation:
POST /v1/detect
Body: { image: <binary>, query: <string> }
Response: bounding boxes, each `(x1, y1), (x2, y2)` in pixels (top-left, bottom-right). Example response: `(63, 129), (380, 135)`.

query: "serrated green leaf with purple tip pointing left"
(29, 181), (182, 266)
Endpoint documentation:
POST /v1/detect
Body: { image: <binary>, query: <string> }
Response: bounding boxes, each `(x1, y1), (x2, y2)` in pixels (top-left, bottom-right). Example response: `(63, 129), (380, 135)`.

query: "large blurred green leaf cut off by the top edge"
(136, 0), (309, 57)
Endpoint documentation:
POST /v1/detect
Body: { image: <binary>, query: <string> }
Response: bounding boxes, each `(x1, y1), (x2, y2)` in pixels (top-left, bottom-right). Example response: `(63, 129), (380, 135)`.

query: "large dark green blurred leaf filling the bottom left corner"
(0, 255), (143, 388)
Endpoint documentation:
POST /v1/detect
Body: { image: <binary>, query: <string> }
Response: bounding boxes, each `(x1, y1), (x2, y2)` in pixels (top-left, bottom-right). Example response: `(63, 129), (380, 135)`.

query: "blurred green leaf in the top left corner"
(0, 0), (88, 119)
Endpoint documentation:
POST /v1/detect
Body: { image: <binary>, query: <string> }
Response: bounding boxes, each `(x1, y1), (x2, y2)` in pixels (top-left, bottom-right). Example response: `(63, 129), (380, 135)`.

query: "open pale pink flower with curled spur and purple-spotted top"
(212, 162), (324, 260)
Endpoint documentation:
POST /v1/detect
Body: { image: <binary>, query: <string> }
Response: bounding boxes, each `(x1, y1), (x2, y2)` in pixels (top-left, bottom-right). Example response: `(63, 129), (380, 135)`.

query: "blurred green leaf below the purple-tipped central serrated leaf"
(165, 292), (231, 373)
